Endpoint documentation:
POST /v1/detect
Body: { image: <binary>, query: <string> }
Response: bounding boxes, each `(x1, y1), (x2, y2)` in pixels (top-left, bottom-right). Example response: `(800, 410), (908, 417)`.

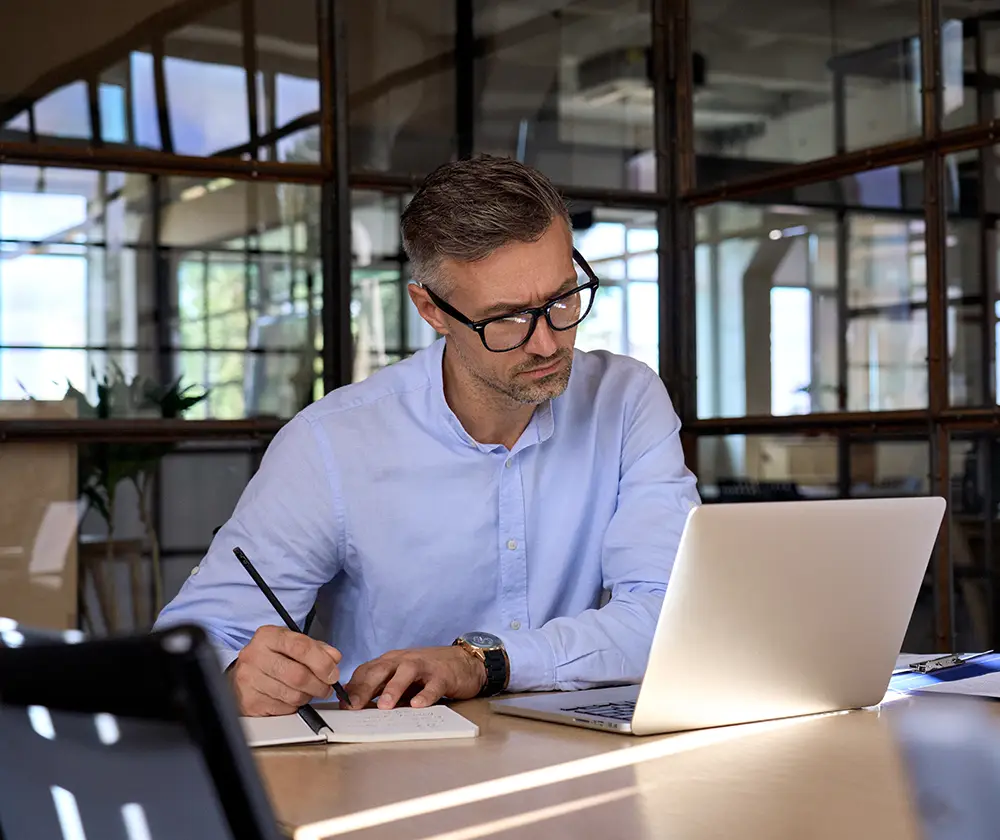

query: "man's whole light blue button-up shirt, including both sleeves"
(156, 339), (699, 691)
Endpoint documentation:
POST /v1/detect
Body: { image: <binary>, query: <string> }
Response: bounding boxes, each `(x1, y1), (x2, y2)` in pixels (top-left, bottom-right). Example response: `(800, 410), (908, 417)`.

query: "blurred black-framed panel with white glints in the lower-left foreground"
(0, 618), (290, 840)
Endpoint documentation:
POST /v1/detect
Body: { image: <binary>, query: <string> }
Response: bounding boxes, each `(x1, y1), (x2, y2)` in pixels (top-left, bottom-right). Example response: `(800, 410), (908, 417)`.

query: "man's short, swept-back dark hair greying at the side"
(400, 155), (571, 294)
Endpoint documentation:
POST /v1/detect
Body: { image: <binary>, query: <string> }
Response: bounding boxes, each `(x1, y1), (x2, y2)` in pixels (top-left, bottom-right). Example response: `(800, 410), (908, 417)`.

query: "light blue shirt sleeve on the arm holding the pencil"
(153, 415), (344, 668)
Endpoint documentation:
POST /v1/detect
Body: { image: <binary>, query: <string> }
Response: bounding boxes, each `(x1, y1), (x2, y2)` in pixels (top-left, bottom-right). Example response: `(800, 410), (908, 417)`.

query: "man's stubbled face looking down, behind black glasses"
(418, 219), (581, 405)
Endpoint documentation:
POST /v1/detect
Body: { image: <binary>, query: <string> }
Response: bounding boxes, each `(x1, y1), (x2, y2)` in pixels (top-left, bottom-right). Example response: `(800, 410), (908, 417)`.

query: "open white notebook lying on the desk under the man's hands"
(240, 706), (479, 747)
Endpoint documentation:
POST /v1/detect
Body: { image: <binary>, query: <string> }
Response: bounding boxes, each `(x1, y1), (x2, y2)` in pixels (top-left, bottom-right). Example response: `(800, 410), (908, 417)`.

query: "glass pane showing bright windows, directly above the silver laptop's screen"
(695, 167), (927, 417)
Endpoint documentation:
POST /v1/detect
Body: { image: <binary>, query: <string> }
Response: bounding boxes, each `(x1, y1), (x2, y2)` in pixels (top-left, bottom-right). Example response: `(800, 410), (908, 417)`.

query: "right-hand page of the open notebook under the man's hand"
(319, 706), (479, 743)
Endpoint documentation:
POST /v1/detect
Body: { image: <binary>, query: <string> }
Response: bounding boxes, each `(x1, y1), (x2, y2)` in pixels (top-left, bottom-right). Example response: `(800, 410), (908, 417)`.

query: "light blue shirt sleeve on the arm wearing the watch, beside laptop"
(503, 369), (700, 691)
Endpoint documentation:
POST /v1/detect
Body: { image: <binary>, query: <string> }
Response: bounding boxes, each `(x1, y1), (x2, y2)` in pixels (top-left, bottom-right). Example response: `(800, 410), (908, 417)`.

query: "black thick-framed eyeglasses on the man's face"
(424, 248), (601, 353)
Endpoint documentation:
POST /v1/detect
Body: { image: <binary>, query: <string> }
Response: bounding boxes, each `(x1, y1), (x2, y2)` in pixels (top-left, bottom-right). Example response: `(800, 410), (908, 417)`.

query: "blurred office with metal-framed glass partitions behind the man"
(0, 0), (1000, 651)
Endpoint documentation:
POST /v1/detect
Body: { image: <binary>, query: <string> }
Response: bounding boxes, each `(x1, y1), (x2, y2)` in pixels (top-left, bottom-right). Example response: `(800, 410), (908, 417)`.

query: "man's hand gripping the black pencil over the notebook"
(228, 625), (341, 717)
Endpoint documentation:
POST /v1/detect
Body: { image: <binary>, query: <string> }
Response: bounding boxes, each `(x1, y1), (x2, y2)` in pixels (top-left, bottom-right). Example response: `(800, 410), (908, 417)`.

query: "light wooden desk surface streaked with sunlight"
(255, 697), (1000, 840)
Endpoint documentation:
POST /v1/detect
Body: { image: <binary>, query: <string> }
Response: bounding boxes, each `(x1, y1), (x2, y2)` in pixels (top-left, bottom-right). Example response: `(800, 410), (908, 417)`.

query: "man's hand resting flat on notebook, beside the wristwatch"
(344, 645), (486, 709)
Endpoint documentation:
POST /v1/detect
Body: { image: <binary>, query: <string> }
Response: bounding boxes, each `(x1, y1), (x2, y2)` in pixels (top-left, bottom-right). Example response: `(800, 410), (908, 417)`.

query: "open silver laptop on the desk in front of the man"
(490, 497), (945, 735)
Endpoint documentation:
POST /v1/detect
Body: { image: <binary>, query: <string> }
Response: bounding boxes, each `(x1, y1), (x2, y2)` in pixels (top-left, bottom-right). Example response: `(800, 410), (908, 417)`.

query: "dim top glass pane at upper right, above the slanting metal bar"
(691, 0), (922, 185)
